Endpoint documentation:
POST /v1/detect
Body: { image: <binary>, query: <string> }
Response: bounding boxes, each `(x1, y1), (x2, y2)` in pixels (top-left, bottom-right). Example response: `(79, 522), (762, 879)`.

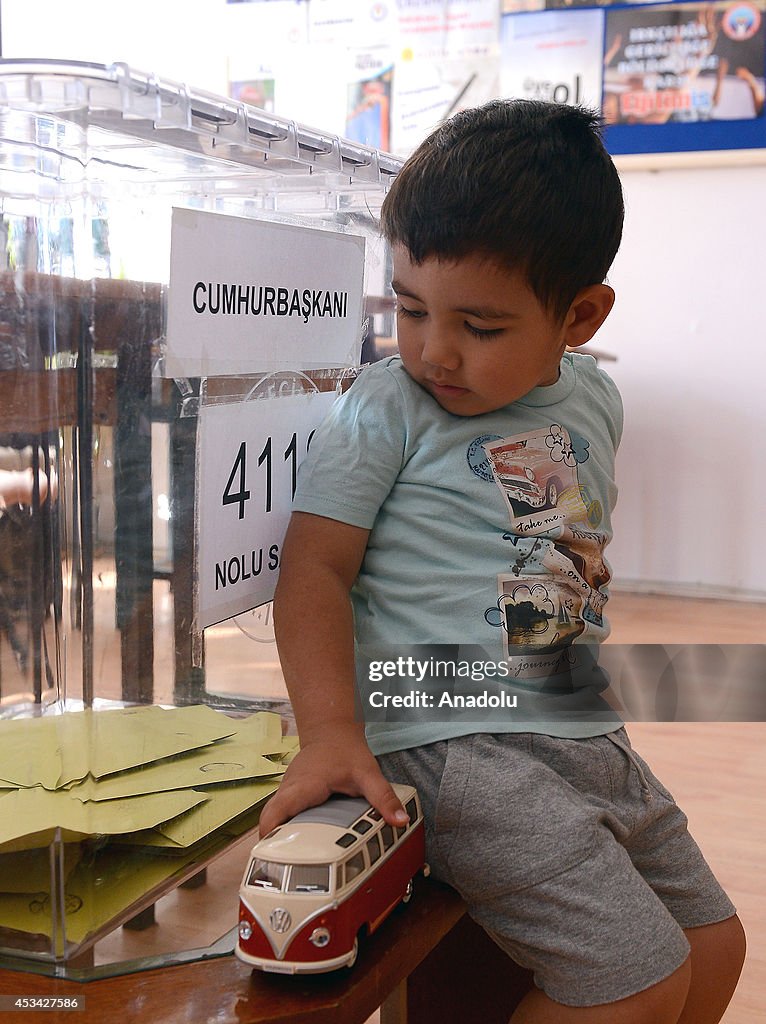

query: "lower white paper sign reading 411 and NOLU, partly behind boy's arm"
(196, 392), (336, 629)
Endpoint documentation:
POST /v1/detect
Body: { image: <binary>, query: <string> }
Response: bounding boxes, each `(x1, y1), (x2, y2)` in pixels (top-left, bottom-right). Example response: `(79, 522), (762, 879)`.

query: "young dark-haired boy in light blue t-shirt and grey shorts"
(261, 100), (743, 1024)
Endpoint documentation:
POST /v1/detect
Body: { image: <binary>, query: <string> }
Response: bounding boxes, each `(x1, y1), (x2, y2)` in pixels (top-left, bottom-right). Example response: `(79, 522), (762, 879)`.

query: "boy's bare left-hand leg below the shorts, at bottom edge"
(510, 959), (703, 1024)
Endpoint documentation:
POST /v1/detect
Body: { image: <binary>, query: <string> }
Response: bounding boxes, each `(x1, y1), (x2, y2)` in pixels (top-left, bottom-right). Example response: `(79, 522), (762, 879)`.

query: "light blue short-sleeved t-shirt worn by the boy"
(293, 353), (623, 754)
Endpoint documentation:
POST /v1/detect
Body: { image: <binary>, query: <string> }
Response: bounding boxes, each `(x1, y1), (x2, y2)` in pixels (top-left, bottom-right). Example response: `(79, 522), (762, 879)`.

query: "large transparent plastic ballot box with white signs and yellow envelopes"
(0, 60), (399, 980)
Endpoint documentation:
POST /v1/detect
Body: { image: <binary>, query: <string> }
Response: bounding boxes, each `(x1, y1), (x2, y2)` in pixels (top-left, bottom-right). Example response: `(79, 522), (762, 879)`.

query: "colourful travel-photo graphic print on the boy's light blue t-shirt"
(483, 424), (609, 656)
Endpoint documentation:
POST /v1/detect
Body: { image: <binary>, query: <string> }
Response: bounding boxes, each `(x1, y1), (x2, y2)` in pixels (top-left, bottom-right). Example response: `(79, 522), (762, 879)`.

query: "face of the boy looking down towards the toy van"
(392, 246), (567, 416)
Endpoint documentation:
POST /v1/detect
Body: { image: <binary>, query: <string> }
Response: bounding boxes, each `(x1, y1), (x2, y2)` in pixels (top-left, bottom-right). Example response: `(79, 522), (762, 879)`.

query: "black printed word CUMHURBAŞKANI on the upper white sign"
(192, 281), (348, 324)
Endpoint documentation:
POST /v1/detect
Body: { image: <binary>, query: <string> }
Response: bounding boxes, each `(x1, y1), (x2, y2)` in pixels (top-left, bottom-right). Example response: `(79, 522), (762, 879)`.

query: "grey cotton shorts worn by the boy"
(378, 729), (735, 1007)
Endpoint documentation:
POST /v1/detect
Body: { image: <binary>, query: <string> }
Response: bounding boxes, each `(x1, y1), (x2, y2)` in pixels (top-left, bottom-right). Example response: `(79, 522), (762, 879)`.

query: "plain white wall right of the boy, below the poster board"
(597, 160), (766, 596)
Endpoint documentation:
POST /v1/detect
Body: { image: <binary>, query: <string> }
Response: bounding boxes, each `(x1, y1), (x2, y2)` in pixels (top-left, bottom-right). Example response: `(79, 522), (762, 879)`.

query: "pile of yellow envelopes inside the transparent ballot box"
(0, 706), (296, 955)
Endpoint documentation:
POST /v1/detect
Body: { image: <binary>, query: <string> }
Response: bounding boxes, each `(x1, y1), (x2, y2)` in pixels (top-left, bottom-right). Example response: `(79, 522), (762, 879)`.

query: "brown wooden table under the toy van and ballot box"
(0, 880), (531, 1024)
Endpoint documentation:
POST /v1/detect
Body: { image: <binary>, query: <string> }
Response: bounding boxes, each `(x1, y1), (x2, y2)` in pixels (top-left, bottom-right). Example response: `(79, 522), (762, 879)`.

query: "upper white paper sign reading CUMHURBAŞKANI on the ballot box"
(165, 209), (365, 377)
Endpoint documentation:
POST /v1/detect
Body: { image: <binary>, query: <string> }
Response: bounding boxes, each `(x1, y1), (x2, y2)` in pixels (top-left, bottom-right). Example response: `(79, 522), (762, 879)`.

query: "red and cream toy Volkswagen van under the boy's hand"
(235, 783), (428, 974)
